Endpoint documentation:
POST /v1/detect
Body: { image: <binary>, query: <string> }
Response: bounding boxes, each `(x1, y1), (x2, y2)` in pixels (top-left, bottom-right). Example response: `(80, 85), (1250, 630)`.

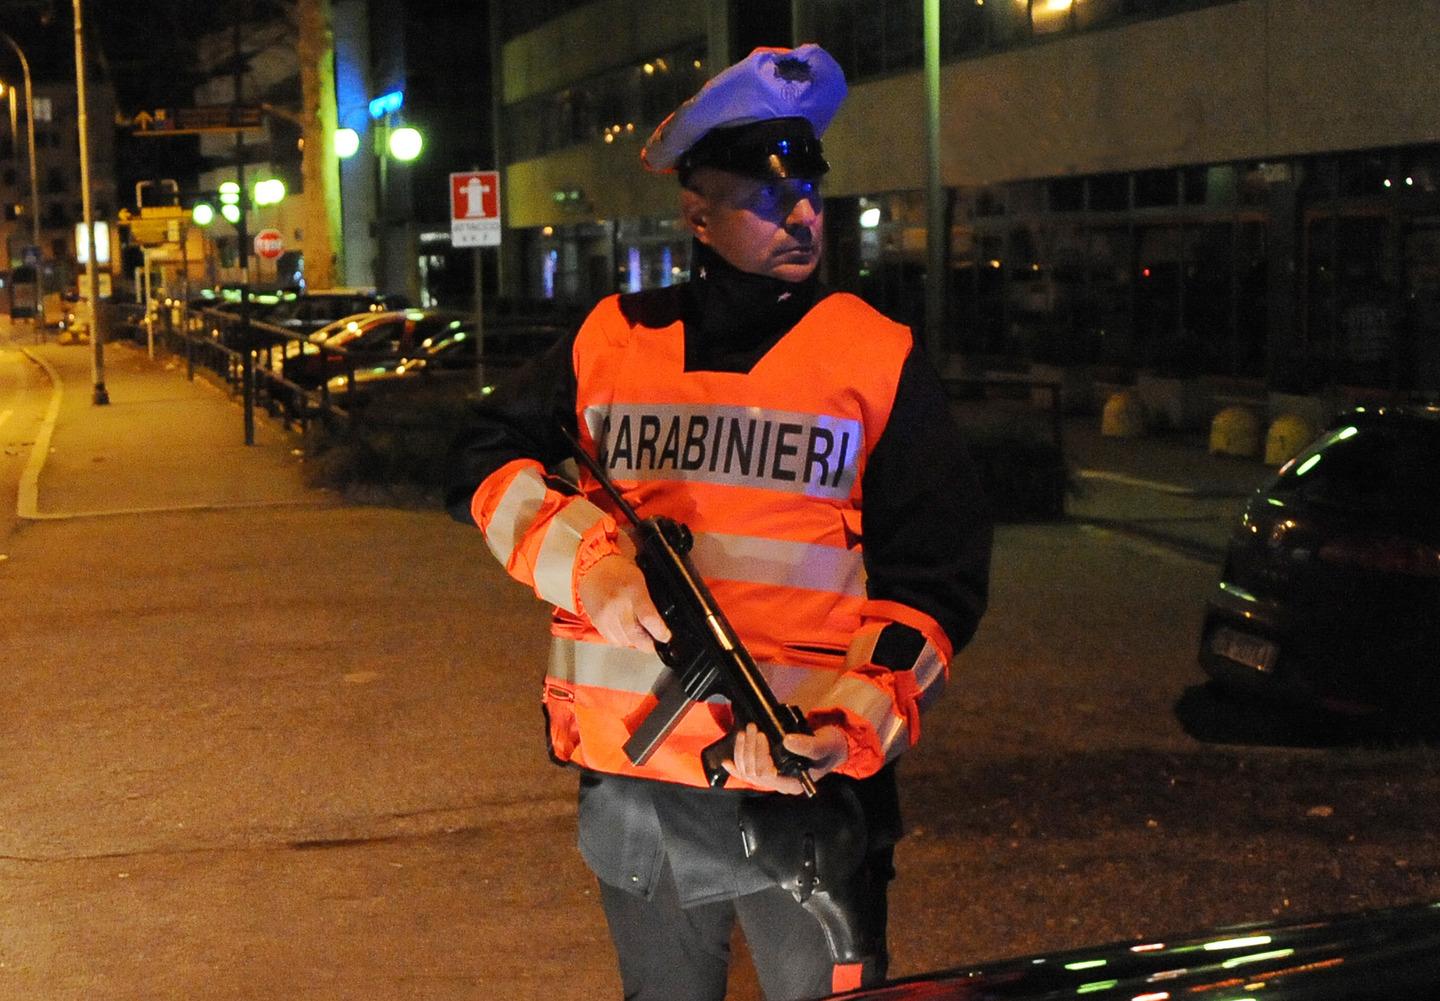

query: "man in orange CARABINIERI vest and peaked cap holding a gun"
(448, 45), (991, 1001)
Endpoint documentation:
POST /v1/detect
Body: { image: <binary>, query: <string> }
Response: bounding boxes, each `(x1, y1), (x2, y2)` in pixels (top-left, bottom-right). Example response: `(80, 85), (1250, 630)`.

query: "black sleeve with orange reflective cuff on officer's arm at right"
(809, 341), (992, 778)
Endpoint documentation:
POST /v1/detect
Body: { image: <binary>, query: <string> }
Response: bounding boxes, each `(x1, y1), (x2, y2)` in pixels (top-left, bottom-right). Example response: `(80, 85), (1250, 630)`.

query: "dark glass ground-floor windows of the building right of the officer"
(829, 145), (1440, 392)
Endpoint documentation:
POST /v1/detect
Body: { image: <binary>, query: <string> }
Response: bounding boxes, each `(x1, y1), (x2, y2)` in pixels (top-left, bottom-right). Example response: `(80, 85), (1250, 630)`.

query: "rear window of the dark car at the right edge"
(1273, 423), (1440, 520)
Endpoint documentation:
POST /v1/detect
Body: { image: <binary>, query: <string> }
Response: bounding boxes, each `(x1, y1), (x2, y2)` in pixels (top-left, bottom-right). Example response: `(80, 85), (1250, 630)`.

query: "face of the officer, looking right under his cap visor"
(680, 167), (825, 281)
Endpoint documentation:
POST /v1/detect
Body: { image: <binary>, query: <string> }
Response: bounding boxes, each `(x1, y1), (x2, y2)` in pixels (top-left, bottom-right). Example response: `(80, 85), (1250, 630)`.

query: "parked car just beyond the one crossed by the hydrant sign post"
(284, 310), (471, 389)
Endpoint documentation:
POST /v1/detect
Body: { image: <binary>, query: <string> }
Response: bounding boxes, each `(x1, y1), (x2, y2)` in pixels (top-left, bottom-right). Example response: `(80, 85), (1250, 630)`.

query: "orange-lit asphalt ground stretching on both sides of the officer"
(0, 334), (1440, 1001)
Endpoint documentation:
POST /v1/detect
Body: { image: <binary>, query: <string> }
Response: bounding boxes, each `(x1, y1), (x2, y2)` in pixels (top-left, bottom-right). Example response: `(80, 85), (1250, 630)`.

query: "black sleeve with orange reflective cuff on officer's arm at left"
(445, 328), (618, 614)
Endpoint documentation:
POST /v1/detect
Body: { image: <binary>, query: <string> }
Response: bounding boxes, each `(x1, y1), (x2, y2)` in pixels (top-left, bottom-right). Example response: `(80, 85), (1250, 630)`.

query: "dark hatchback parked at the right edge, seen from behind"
(1200, 406), (1440, 719)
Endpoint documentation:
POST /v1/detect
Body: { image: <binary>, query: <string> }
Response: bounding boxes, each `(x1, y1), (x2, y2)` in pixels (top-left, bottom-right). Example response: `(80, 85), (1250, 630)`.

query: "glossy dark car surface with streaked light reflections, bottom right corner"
(834, 903), (1440, 1001)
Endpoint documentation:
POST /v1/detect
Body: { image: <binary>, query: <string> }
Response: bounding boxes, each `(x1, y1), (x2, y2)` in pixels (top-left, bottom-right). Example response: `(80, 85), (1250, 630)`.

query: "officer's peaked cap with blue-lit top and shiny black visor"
(639, 45), (845, 177)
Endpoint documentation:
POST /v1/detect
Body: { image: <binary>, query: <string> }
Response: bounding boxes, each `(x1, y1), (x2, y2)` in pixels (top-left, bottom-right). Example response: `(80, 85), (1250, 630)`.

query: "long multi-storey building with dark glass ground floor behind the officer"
(498, 0), (1440, 392)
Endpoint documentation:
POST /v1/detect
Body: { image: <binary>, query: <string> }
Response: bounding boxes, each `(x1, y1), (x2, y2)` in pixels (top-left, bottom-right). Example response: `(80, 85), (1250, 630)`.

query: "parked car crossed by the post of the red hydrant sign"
(327, 318), (566, 405)
